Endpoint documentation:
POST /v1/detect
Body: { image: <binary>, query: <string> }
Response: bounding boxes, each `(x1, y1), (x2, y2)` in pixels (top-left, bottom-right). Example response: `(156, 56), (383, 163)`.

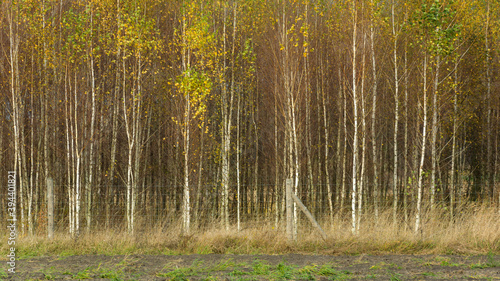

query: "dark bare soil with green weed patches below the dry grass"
(0, 254), (500, 280)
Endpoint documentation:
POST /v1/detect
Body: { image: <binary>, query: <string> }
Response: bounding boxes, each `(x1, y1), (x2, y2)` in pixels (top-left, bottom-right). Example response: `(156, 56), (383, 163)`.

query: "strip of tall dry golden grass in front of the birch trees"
(0, 202), (500, 257)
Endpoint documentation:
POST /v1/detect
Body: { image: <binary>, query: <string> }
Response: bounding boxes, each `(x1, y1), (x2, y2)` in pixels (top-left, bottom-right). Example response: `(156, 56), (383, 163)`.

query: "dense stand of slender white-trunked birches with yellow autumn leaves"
(0, 0), (500, 234)
